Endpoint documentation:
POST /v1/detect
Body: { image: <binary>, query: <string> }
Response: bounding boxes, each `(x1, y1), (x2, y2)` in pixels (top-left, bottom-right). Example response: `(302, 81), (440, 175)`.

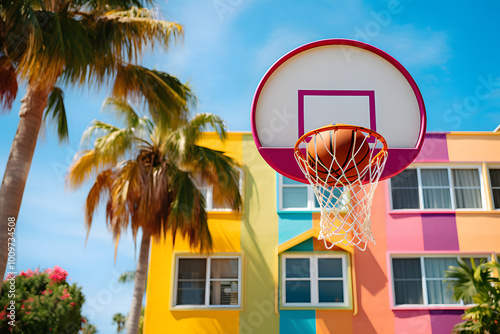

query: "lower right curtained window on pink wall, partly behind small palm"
(392, 256), (486, 306)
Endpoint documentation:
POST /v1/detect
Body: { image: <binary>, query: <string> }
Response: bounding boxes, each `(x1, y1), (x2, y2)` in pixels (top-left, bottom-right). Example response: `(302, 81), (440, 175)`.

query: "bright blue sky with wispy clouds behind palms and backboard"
(0, 0), (500, 333)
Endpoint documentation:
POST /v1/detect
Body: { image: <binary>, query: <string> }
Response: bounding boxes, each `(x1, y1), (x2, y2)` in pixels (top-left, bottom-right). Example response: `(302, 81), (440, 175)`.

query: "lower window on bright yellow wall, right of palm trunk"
(174, 256), (241, 308)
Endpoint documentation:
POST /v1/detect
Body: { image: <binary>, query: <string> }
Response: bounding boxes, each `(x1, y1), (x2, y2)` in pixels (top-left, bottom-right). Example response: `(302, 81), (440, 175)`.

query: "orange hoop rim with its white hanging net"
(294, 125), (387, 250)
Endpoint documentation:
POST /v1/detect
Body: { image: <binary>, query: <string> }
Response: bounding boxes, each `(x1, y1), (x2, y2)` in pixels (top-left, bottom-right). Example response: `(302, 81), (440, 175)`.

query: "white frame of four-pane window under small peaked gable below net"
(281, 253), (350, 308)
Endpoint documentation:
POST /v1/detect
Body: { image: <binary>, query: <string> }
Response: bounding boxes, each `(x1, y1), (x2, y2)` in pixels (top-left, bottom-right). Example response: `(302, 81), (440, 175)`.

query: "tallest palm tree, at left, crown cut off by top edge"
(0, 0), (192, 276)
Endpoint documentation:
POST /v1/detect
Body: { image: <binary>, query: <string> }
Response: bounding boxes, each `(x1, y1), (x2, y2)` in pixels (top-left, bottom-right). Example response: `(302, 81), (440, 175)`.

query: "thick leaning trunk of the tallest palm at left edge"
(0, 83), (52, 282)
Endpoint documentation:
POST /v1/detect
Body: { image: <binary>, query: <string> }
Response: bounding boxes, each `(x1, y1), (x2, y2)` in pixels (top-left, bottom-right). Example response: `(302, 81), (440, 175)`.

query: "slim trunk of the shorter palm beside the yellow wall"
(127, 230), (151, 334)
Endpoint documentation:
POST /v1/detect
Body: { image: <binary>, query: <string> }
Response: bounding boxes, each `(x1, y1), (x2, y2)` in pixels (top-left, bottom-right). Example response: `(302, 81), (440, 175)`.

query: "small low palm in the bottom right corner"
(445, 259), (500, 334)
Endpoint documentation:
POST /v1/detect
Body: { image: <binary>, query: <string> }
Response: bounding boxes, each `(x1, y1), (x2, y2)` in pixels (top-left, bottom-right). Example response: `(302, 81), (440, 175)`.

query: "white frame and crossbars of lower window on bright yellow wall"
(173, 256), (241, 308)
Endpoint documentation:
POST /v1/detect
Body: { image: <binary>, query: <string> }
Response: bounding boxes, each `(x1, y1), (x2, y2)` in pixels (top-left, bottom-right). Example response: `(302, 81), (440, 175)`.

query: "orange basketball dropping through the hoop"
(307, 129), (370, 186)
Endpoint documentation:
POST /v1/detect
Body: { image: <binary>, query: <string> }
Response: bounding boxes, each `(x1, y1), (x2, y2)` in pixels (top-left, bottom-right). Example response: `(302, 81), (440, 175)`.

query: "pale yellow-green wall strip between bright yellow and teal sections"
(239, 134), (279, 334)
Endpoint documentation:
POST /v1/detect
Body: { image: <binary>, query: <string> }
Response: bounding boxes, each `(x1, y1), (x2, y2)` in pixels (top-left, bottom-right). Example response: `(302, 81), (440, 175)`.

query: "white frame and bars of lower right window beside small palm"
(391, 255), (488, 306)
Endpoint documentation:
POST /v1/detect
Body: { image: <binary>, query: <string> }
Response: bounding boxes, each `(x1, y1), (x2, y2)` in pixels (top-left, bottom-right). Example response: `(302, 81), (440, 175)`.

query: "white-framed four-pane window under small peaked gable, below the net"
(282, 255), (349, 307)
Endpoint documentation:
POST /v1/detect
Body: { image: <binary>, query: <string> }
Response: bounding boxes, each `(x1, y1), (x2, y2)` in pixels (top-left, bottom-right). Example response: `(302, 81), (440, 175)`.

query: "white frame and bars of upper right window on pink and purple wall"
(390, 166), (484, 210)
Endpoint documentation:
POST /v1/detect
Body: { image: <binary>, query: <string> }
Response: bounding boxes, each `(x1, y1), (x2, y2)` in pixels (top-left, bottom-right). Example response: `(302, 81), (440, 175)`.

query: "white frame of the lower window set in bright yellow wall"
(172, 255), (241, 309)
